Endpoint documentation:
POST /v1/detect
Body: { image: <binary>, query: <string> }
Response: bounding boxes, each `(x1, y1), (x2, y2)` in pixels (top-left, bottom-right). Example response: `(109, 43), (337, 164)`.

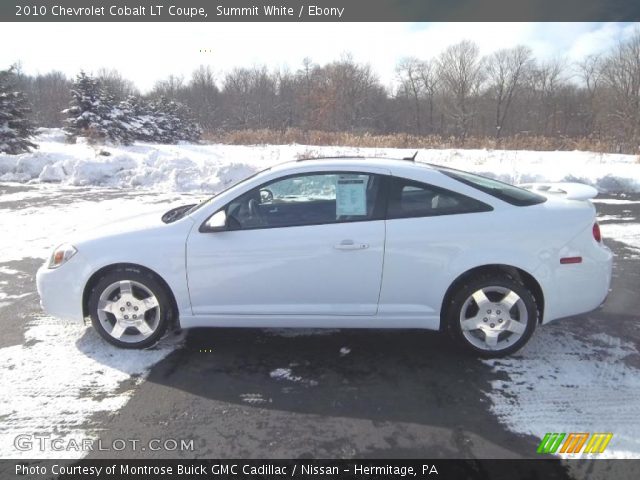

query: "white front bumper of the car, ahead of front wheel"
(36, 253), (85, 323)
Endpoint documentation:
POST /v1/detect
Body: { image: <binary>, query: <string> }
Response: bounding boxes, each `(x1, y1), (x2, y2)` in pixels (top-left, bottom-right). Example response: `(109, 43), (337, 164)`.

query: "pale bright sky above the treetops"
(0, 22), (638, 91)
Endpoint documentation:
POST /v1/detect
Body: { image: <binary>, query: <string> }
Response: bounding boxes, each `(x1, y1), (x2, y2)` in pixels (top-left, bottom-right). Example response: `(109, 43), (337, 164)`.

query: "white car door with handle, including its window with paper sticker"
(186, 172), (385, 315)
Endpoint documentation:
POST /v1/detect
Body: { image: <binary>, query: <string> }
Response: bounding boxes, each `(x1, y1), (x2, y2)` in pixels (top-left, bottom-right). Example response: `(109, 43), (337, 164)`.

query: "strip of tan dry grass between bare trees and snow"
(202, 128), (638, 154)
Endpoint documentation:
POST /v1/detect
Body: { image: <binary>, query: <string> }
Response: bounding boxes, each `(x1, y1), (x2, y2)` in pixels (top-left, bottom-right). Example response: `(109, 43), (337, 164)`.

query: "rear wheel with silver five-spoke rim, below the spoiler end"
(446, 273), (538, 358)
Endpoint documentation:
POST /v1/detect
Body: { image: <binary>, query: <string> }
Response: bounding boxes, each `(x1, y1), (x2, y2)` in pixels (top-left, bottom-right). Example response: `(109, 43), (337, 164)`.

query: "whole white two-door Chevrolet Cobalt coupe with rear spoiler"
(37, 158), (612, 356)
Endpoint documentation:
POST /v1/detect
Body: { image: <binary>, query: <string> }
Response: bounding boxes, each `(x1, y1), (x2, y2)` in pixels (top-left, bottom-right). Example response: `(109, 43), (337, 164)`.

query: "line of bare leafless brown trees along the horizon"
(3, 30), (640, 153)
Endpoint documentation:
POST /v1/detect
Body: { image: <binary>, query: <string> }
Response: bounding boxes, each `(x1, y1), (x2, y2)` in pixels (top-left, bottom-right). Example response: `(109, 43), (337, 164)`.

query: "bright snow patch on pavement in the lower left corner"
(0, 316), (180, 458)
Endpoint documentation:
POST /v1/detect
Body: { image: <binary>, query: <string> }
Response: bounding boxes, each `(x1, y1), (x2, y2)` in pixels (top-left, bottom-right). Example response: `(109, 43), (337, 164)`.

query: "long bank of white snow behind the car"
(0, 129), (640, 193)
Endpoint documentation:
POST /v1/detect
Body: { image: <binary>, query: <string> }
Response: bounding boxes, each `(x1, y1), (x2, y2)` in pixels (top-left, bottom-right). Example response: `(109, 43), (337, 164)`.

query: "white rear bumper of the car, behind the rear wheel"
(543, 245), (613, 323)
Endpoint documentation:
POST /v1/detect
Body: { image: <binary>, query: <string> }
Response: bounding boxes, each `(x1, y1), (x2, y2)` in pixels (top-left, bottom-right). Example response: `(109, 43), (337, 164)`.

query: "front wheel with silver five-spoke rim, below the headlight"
(89, 268), (172, 349)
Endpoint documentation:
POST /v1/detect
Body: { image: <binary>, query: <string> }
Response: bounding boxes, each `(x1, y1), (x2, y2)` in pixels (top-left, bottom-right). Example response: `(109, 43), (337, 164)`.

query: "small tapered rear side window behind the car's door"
(387, 177), (492, 219)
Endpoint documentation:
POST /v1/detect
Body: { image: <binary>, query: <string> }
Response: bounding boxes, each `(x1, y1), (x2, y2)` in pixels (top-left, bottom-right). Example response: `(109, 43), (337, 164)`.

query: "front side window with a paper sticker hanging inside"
(227, 172), (382, 229)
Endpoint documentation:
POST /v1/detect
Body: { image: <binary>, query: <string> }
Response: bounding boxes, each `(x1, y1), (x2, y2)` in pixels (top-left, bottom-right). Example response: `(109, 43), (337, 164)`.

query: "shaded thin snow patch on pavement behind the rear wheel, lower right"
(485, 327), (640, 458)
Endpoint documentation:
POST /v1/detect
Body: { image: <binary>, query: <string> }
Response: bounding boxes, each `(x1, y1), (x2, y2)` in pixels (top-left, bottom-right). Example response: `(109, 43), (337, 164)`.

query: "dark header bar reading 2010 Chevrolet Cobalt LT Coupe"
(0, 0), (640, 22)
